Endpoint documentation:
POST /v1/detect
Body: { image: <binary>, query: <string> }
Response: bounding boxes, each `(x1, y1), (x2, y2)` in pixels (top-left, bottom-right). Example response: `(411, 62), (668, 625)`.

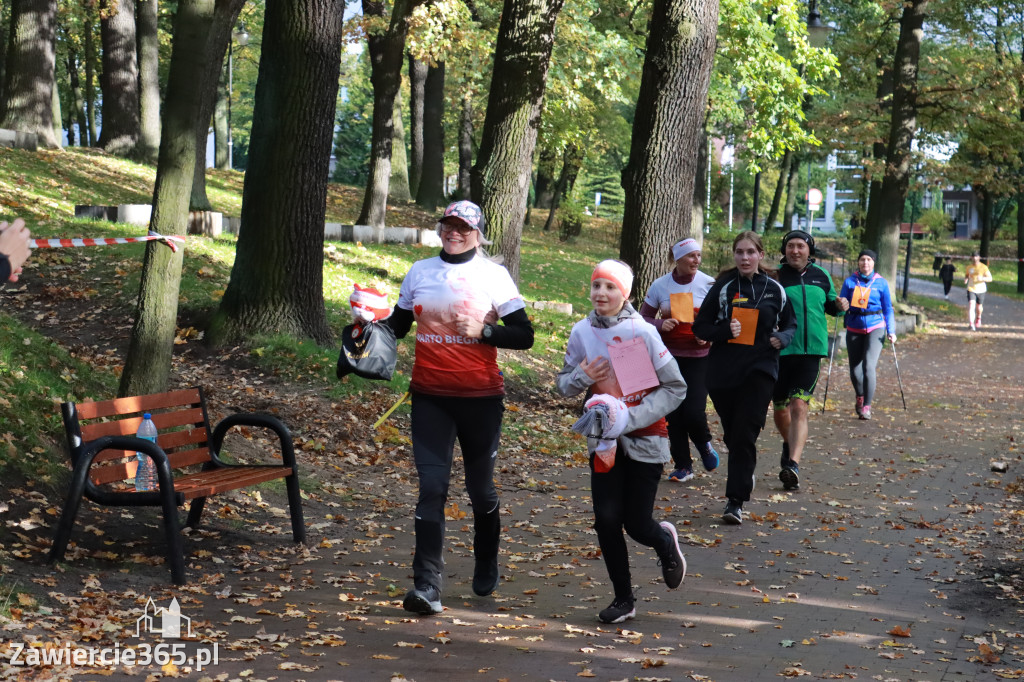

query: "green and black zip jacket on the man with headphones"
(778, 262), (840, 357)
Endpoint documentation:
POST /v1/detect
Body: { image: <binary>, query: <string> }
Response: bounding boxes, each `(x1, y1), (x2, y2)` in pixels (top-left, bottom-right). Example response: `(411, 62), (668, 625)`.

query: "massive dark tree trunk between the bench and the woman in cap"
(210, 0), (344, 345)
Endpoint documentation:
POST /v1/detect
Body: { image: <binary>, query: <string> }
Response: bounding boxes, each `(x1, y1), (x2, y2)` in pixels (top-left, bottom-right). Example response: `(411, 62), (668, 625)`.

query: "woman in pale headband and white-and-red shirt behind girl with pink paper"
(640, 239), (719, 482)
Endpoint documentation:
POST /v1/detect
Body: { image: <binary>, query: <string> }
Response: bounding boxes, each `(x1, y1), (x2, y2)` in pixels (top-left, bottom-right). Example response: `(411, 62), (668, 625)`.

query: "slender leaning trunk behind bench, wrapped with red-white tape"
(118, 0), (214, 396)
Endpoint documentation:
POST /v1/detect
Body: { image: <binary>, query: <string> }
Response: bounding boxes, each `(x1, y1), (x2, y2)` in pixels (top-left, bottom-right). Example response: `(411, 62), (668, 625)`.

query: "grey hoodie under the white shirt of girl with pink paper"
(555, 303), (686, 464)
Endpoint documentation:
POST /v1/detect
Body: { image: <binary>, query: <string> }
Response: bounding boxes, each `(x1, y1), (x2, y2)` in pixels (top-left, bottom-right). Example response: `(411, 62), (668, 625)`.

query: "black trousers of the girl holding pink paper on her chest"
(590, 450), (672, 599)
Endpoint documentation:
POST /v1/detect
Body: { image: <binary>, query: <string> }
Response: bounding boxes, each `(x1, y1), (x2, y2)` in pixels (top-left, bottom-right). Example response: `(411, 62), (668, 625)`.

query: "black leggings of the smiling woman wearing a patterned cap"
(412, 393), (505, 590)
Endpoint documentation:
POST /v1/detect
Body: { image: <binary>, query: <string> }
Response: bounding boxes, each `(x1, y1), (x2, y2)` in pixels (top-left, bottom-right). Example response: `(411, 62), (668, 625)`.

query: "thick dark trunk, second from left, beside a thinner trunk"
(99, 0), (140, 157)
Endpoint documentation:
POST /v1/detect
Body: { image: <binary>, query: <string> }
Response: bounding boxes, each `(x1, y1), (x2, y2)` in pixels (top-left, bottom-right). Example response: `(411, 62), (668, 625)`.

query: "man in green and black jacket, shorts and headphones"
(772, 229), (850, 491)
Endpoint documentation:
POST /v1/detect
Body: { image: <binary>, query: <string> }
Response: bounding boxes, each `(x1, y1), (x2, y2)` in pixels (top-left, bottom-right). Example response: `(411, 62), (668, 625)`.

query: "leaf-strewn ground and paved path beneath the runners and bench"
(0, 150), (1024, 682)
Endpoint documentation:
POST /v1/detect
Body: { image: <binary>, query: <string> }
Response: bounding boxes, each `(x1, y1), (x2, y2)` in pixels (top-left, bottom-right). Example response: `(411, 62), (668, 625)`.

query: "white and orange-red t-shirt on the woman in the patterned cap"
(398, 256), (526, 397)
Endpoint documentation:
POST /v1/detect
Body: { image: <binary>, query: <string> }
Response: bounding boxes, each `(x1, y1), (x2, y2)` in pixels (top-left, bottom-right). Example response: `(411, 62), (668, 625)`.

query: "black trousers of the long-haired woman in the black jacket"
(709, 372), (775, 503)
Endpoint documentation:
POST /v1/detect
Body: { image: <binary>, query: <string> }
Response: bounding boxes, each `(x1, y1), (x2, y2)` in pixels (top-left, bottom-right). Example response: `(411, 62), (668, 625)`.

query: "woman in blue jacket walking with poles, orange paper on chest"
(839, 249), (896, 419)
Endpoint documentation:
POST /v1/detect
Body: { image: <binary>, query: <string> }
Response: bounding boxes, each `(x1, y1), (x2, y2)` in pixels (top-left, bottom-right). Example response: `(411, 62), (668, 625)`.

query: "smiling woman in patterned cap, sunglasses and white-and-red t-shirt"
(387, 201), (534, 615)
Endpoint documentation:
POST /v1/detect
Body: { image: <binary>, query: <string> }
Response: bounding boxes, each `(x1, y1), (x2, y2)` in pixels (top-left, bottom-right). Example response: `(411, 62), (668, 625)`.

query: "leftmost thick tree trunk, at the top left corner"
(0, 0), (60, 148)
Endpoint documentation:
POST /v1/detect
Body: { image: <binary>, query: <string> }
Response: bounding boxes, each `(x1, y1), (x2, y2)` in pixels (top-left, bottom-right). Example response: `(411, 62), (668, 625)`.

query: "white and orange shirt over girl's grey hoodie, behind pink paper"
(565, 312), (675, 437)
